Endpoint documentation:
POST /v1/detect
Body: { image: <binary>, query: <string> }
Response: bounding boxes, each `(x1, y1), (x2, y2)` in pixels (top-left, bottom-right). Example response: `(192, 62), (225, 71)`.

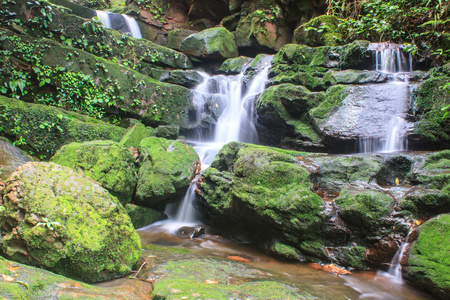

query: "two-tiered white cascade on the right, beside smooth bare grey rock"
(358, 43), (412, 153)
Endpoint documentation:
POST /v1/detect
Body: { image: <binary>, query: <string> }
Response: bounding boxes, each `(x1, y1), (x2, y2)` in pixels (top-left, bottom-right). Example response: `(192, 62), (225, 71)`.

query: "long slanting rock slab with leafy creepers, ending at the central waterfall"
(0, 30), (191, 126)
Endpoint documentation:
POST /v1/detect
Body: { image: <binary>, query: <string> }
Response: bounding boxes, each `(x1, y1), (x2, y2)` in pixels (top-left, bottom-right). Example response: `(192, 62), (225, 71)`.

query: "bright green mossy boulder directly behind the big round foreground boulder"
(51, 141), (137, 205)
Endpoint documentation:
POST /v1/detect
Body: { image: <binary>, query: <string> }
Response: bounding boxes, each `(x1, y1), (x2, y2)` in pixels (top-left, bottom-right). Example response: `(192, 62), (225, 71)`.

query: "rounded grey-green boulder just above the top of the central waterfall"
(181, 27), (238, 60)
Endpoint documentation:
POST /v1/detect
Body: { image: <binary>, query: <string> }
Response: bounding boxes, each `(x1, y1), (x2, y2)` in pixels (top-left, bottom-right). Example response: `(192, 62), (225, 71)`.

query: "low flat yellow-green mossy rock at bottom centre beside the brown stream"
(153, 259), (314, 299)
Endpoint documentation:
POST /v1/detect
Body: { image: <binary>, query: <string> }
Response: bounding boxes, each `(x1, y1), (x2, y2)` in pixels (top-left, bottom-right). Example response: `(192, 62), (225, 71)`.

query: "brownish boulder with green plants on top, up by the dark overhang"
(236, 10), (292, 52)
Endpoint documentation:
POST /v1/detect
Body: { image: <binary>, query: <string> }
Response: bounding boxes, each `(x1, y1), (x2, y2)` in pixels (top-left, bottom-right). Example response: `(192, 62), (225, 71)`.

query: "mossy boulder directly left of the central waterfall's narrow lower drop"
(136, 137), (200, 208)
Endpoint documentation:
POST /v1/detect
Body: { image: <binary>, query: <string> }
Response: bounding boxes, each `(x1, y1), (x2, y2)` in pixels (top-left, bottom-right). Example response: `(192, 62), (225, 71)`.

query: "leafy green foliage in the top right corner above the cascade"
(327, 0), (450, 60)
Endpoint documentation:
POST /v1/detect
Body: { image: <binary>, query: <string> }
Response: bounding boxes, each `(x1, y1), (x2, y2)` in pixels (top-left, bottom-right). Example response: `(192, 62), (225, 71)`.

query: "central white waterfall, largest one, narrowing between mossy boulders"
(171, 57), (272, 223)
